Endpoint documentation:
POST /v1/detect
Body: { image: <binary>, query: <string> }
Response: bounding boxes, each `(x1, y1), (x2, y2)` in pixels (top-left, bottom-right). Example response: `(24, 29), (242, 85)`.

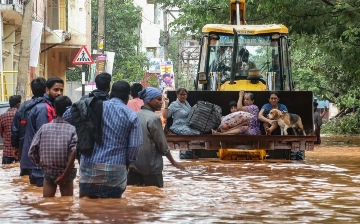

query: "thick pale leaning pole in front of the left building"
(16, 0), (34, 100)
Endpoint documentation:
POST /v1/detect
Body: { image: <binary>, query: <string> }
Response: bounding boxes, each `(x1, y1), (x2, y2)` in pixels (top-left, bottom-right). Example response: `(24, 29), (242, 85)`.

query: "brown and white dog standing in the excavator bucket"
(268, 109), (306, 135)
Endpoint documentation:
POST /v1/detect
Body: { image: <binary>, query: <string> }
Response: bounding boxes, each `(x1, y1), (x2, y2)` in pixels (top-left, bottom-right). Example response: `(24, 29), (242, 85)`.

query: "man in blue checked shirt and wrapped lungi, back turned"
(79, 81), (143, 198)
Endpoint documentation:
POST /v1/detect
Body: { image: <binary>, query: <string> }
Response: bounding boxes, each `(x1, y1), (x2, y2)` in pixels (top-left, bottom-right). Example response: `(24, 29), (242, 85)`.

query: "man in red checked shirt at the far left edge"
(0, 95), (21, 164)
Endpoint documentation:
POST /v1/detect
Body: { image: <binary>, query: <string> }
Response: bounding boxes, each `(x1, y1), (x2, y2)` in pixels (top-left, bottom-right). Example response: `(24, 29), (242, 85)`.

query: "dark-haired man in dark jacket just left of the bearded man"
(11, 77), (46, 176)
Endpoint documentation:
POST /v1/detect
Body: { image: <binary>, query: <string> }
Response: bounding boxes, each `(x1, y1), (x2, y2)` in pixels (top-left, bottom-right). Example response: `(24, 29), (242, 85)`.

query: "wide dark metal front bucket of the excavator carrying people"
(165, 91), (316, 160)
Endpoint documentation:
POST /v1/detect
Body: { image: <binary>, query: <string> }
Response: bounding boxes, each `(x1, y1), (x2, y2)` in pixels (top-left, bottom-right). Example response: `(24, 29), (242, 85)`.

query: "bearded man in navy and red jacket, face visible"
(20, 77), (64, 187)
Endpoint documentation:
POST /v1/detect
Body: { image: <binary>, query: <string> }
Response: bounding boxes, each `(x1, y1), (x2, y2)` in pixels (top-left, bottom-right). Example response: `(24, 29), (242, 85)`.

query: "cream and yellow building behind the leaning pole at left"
(0, 0), (91, 98)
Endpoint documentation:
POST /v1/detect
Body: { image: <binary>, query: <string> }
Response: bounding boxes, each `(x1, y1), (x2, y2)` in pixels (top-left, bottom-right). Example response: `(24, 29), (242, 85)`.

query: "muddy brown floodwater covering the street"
(0, 136), (360, 223)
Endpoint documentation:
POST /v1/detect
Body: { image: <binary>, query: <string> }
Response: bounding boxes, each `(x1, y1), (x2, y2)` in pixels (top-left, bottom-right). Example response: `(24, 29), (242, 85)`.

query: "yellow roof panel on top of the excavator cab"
(202, 24), (289, 35)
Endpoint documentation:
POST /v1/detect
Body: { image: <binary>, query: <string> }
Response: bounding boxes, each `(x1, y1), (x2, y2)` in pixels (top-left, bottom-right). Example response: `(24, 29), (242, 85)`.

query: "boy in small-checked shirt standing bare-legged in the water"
(29, 96), (77, 197)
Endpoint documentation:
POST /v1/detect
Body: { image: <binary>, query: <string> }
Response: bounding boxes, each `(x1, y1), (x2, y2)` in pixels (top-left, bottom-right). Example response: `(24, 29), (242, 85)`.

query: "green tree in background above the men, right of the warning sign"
(91, 0), (148, 82)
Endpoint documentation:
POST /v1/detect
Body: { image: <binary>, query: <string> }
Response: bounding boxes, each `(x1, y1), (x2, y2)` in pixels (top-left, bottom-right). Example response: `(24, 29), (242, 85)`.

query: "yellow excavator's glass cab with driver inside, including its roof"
(195, 24), (294, 91)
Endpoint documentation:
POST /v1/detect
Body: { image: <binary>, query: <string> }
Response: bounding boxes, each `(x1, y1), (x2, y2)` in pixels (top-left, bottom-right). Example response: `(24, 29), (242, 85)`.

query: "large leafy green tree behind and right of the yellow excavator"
(157, 0), (360, 106)
